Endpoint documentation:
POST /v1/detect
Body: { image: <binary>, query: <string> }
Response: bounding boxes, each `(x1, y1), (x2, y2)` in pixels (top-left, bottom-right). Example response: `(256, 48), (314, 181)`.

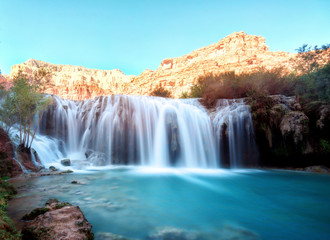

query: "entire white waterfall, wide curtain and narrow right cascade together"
(33, 95), (257, 168)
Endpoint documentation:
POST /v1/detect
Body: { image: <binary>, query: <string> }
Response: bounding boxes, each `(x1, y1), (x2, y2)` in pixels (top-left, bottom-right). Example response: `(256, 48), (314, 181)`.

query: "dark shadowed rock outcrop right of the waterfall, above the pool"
(247, 95), (330, 168)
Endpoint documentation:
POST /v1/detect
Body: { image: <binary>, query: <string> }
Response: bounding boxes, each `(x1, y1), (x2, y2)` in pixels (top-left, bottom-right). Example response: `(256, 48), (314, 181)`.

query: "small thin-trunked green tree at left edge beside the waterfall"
(0, 72), (52, 150)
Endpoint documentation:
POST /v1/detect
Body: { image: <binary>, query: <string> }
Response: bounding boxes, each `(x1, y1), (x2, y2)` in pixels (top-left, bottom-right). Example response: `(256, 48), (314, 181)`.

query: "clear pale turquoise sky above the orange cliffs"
(0, 0), (330, 75)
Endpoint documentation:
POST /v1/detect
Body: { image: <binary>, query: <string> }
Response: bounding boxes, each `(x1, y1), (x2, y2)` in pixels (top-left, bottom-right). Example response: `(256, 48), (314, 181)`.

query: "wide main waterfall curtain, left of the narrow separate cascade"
(39, 95), (218, 168)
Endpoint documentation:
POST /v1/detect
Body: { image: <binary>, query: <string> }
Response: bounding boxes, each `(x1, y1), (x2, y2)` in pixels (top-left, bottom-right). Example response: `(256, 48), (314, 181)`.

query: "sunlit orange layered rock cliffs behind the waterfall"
(11, 32), (294, 100)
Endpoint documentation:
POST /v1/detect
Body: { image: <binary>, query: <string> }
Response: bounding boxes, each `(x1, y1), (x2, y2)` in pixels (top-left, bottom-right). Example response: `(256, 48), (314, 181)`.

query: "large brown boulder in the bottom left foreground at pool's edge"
(22, 199), (94, 240)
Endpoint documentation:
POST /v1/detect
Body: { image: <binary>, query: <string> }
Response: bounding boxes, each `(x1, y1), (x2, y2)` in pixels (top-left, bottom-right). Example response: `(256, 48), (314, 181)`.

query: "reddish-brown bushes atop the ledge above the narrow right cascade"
(183, 68), (296, 107)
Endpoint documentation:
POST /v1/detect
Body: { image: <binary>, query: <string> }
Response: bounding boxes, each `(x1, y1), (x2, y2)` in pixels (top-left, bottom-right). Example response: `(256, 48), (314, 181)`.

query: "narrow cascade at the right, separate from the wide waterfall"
(213, 99), (258, 168)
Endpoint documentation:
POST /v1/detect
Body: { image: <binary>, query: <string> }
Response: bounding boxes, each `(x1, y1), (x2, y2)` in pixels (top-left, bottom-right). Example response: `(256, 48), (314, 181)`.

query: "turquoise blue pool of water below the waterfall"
(10, 168), (330, 240)
